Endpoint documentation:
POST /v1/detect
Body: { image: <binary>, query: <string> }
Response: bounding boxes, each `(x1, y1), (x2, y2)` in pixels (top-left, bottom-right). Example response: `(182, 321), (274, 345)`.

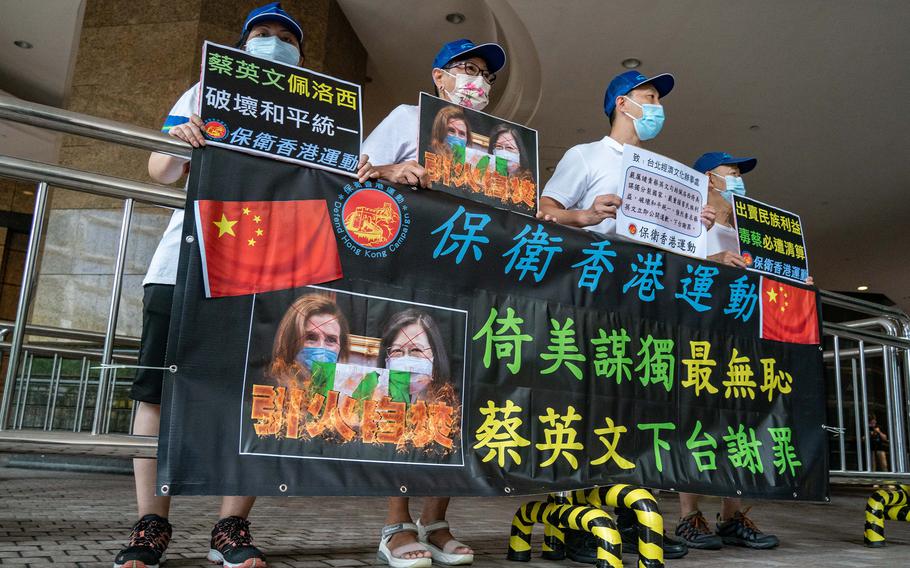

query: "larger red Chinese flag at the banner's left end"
(196, 199), (342, 298)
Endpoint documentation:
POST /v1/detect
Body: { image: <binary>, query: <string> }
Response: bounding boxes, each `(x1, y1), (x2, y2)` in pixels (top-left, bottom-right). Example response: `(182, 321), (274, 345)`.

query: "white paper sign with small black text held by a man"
(616, 144), (708, 258)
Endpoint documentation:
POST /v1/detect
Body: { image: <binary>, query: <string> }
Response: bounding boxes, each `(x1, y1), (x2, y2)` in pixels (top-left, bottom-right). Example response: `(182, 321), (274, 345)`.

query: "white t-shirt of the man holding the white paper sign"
(541, 136), (622, 235)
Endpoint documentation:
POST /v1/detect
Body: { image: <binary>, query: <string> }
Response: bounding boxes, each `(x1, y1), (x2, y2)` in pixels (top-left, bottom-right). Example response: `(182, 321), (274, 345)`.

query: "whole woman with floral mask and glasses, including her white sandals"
(358, 39), (506, 568)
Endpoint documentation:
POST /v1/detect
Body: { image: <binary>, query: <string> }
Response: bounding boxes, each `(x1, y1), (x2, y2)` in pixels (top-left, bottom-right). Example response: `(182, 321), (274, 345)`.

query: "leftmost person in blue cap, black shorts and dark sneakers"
(114, 2), (303, 568)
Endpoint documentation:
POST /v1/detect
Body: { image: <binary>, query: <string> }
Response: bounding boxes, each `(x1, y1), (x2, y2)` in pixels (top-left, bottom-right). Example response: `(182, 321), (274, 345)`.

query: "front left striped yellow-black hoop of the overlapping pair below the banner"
(508, 498), (622, 568)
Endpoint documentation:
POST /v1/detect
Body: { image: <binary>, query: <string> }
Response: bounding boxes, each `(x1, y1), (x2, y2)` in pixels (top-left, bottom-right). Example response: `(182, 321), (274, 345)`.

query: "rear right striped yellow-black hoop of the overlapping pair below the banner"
(569, 484), (664, 568)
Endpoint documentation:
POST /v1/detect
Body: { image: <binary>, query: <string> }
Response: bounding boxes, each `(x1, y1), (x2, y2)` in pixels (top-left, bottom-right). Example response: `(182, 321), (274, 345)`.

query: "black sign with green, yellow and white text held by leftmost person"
(199, 42), (363, 173)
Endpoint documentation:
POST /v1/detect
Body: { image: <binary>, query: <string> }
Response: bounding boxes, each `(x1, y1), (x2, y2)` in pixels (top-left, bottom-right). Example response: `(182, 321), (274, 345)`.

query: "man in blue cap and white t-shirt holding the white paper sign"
(538, 70), (715, 235)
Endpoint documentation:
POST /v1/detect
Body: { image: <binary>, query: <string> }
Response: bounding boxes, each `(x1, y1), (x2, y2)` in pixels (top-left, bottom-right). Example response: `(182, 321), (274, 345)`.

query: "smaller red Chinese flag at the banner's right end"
(761, 277), (819, 344)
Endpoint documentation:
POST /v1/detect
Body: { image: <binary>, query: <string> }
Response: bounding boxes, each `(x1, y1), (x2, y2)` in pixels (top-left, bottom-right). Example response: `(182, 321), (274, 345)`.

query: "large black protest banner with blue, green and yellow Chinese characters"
(158, 148), (828, 500)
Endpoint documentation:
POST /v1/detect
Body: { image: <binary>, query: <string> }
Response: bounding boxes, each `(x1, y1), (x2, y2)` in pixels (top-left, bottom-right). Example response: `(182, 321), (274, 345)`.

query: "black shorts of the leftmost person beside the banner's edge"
(130, 284), (174, 404)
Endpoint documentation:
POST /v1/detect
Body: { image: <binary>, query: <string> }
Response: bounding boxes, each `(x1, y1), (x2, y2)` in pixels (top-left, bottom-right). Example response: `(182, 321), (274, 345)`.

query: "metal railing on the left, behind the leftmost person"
(0, 95), (192, 448)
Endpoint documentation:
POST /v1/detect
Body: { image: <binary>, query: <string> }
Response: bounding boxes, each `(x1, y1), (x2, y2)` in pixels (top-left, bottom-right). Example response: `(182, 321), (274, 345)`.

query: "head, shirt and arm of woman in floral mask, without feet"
(358, 39), (506, 192)
